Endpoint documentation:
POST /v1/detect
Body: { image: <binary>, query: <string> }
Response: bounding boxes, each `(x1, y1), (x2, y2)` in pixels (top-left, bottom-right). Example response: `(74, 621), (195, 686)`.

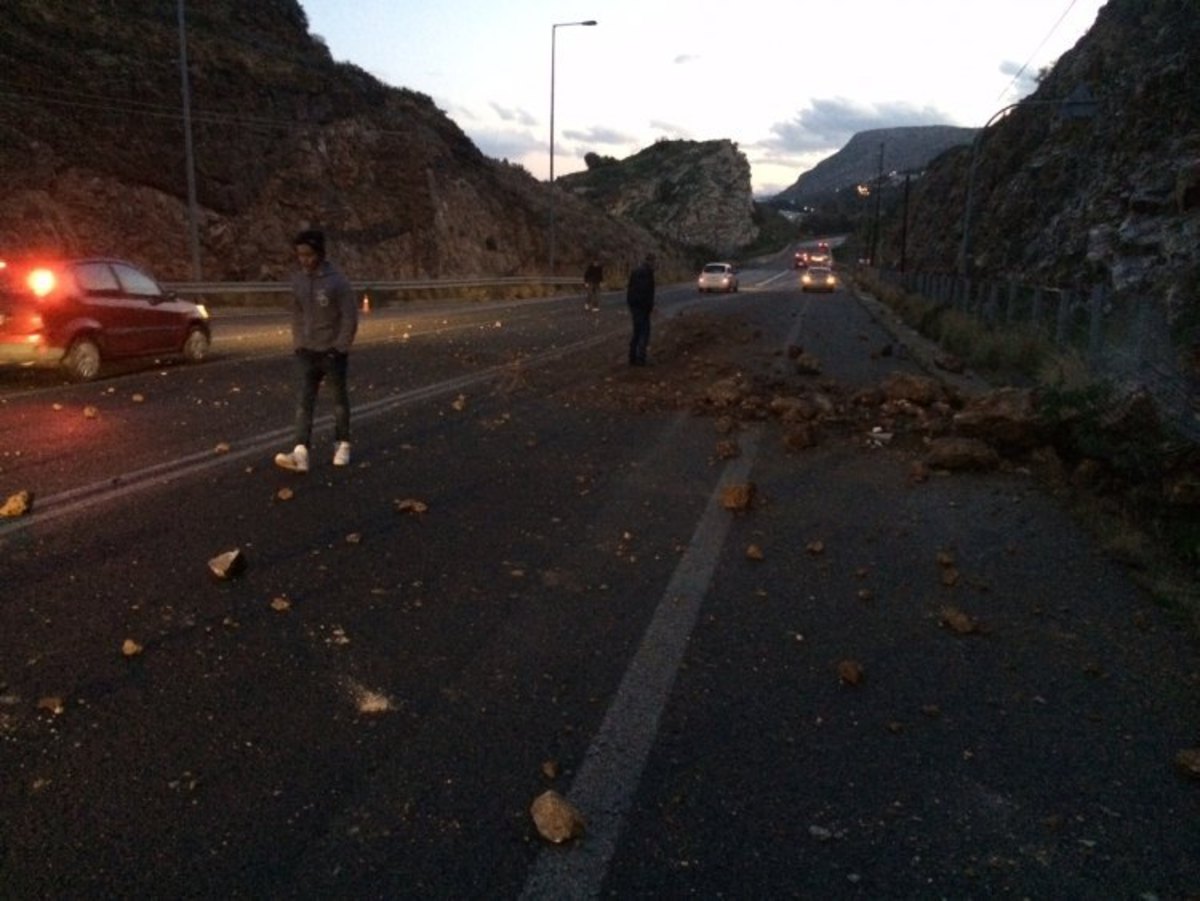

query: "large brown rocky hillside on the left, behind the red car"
(0, 0), (671, 280)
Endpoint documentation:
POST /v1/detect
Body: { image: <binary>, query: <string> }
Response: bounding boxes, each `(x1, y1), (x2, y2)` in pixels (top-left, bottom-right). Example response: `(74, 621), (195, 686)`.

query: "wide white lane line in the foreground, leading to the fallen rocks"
(521, 427), (762, 901)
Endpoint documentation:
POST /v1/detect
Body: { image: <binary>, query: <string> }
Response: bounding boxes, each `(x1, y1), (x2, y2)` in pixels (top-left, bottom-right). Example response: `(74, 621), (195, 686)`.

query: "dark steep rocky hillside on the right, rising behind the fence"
(883, 0), (1200, 314)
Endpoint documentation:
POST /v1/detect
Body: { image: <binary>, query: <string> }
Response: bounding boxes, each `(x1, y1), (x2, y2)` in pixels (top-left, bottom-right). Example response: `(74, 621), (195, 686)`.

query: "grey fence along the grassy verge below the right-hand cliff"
(875, 269), (1200, 444)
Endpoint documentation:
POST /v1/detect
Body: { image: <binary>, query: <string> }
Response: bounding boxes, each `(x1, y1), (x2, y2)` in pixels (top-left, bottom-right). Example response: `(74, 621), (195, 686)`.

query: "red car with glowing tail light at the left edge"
(0, 259), (212, 382)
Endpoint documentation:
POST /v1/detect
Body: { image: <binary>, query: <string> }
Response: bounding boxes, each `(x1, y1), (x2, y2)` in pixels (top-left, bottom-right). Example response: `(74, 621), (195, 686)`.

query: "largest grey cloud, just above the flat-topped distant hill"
(761, 97), (953, 156)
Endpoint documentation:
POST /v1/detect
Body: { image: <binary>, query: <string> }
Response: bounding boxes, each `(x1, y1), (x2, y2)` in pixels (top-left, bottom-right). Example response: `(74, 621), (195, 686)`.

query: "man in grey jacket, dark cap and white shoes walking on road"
(275, 229), (359, 473)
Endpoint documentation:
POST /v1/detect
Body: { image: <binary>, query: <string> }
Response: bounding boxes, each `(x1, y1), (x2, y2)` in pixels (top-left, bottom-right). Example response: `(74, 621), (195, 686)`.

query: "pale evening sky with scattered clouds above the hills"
(300, 0), (1105, 197)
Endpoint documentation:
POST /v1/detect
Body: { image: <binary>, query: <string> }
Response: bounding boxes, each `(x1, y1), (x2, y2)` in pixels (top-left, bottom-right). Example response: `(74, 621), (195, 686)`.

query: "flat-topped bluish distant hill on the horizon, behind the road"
(766, 125), (977, 209)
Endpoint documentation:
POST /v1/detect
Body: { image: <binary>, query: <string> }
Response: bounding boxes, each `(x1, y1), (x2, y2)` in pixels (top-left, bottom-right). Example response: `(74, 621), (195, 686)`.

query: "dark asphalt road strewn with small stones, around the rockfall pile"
(0, 263), (1200, 899)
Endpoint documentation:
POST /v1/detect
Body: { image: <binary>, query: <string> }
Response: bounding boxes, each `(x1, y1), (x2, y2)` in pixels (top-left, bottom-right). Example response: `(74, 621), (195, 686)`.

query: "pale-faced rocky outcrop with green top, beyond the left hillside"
(559, 140), (758, 256)
